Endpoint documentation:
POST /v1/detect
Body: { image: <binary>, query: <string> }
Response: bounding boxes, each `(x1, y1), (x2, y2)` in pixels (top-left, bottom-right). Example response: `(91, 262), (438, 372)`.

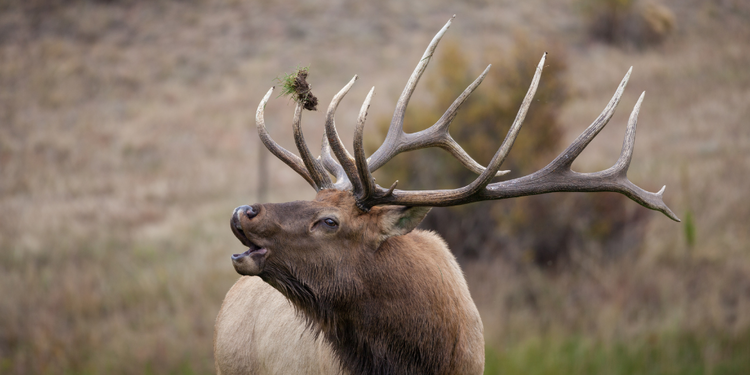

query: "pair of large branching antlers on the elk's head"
(256, 16), (680, 221)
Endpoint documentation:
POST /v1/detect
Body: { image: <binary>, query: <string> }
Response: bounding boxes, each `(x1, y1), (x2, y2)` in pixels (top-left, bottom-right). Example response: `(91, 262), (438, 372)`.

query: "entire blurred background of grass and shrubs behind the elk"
(0, 0), (750, 374)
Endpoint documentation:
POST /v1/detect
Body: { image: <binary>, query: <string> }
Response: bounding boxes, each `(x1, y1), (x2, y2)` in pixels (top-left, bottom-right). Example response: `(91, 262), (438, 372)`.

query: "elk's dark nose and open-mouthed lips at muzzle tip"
(230, 206), (268, 276)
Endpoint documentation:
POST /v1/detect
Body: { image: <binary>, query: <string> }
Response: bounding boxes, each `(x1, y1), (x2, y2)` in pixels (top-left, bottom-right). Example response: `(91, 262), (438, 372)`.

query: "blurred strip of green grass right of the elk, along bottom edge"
(484, 332), (750, 375)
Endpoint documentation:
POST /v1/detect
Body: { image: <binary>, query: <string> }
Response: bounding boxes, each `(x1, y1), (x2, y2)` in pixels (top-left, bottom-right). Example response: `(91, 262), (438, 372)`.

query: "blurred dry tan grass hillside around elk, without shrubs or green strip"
(0, 0), (750, 374)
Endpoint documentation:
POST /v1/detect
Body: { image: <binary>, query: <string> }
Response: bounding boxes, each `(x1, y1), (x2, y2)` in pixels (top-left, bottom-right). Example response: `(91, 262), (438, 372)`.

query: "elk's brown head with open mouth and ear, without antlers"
(231, 189), (430, 286)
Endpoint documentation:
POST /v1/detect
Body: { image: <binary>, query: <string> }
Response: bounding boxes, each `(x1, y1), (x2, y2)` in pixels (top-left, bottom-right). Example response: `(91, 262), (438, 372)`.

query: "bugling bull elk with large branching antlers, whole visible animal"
(214, 19), (679, 375)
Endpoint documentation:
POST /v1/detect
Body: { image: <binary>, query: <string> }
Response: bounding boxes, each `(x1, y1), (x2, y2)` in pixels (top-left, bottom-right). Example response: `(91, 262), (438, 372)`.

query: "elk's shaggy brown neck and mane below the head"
(260, 231), (476, 375)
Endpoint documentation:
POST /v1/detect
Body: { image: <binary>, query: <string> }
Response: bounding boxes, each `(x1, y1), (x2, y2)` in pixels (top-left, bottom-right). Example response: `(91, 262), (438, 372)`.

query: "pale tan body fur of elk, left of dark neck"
(214, 276), (344, 375)
